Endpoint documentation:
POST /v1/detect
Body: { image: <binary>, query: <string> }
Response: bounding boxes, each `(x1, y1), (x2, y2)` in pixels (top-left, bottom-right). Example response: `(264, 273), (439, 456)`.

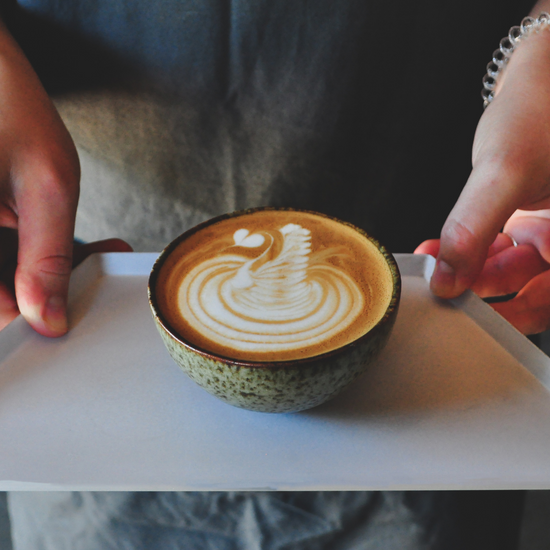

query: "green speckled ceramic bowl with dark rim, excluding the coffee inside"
(148, 209), (401, 413)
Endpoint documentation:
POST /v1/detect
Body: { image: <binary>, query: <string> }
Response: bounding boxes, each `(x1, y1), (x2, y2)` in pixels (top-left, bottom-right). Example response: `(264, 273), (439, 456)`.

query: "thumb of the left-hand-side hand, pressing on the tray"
(15, 162), (78, 336)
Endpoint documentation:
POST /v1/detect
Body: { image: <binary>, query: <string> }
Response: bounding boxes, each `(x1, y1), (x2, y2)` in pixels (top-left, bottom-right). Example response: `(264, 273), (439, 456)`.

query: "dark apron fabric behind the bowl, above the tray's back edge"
(11, 0), (530, 252)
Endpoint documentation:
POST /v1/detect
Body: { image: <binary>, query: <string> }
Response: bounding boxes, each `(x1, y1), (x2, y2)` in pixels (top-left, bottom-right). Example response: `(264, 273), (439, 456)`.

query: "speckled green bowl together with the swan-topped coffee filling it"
(149, 208), (400, 412)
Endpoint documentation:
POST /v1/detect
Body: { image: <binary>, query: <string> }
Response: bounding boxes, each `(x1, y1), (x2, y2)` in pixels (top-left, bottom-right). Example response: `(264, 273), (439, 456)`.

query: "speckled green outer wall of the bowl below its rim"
(151, 308), (397, 413)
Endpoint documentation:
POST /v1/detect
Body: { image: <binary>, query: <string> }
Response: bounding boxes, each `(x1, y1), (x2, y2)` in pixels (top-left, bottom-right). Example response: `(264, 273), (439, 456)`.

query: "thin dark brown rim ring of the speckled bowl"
(147, 206), (401, 368)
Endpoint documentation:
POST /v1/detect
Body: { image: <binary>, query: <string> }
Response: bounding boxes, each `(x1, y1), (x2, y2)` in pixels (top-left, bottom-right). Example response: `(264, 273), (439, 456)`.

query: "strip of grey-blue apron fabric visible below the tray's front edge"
(5, 491), (523, 550)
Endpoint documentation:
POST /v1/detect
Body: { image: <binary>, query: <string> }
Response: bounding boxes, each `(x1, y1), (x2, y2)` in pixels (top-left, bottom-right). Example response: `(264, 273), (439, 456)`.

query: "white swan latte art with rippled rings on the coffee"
(178, 223), (370, 353)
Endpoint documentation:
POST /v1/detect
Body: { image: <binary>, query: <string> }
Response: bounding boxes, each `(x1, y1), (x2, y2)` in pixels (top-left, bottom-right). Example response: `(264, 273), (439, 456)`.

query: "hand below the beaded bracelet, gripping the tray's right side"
(416, 21), (550, 333)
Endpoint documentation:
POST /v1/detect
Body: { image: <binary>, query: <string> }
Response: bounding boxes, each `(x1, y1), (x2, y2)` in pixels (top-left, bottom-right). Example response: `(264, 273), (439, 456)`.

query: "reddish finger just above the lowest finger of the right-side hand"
(472, 245), (550, 297)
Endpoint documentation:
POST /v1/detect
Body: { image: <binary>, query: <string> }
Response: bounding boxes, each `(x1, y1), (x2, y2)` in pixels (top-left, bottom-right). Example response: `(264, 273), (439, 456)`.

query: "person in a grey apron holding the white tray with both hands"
(0, 0), (550, 550)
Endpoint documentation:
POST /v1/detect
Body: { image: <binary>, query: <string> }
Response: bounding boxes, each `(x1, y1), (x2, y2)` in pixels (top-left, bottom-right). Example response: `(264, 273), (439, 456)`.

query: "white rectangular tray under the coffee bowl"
(0, 254), (550, 490)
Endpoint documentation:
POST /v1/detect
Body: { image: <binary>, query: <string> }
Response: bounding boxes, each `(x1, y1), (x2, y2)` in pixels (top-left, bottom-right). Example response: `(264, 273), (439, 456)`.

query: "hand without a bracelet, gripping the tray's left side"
(0, 22), (133, 336)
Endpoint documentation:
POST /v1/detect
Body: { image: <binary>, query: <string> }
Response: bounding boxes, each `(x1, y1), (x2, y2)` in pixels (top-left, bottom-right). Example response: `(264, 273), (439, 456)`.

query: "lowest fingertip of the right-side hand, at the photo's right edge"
(491, 271), (550, 334)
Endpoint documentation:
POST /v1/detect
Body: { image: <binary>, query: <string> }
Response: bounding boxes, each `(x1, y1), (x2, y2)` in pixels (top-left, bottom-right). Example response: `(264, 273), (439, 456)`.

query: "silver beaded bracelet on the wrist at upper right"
(481, 12), (550, 109)
